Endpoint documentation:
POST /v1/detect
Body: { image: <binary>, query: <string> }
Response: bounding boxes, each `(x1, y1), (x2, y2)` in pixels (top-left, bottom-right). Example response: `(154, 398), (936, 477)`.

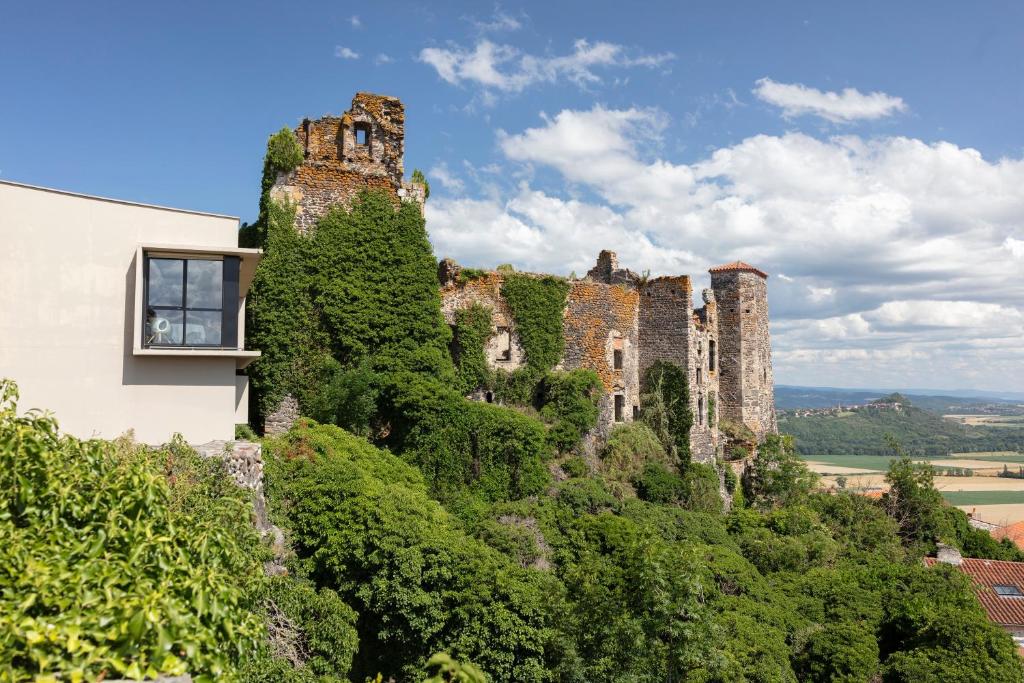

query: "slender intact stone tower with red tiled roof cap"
(710, 261), (776, 438)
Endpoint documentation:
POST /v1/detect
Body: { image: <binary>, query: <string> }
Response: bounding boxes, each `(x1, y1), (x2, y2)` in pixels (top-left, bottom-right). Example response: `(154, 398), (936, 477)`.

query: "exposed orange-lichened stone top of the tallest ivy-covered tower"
(270, 92), (425, 233)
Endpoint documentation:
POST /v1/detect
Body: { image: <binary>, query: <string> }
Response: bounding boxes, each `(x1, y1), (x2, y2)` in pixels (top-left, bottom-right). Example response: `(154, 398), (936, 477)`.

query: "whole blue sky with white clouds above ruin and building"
(0, 2), (1024, 390)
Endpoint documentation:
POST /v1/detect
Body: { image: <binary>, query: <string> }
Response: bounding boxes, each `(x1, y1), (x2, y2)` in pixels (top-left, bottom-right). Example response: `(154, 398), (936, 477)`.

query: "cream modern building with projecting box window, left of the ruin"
(0, 180), (260, 443)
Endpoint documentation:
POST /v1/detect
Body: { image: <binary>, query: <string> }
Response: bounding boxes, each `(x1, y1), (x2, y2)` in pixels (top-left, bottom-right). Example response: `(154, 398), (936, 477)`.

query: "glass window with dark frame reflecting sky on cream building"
(143, 256), (238, 346)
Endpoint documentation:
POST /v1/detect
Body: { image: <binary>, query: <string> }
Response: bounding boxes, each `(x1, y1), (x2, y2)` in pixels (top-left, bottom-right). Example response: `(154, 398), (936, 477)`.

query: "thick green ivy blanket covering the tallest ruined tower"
(247, 187), (454, 416)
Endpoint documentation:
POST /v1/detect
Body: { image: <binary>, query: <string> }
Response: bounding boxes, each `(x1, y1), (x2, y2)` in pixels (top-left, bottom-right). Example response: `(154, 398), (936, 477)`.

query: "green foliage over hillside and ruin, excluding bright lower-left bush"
(234, 129), (1022, 683)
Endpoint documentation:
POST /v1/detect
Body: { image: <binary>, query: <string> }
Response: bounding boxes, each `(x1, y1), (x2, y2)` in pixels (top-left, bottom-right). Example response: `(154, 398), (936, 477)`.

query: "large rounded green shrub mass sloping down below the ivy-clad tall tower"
(260, 422), (560, 681)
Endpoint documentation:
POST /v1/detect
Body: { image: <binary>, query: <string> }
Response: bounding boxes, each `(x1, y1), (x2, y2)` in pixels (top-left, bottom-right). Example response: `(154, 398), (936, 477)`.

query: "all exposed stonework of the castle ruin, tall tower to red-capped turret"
(266, 92), (776, 462)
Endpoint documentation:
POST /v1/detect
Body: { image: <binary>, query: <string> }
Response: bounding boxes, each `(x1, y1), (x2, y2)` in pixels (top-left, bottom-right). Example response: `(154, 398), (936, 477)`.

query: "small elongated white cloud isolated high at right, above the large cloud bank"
(753, 78), (907, 123)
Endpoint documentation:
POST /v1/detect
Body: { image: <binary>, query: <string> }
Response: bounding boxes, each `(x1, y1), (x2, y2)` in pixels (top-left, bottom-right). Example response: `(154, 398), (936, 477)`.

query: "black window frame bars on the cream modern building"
(141, 252), (242, 350)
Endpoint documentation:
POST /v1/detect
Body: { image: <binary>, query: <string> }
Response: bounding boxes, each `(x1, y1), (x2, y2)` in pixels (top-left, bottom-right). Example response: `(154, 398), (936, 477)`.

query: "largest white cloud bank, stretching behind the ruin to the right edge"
(427, 102), (1024, 388)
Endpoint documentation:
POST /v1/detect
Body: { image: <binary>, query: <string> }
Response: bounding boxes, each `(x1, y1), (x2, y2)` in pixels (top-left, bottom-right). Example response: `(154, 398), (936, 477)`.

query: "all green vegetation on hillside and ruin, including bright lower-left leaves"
(6, 130), (1024, 683)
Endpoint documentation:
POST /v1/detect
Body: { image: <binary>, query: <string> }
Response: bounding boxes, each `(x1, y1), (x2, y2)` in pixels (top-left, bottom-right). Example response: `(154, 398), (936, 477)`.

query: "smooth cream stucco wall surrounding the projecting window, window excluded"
(0, 181), (260, 443)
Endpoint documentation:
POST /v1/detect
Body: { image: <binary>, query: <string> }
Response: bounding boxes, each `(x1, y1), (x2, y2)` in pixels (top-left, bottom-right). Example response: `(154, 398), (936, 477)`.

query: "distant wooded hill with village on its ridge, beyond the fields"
(778, 394), (1024, 456)
